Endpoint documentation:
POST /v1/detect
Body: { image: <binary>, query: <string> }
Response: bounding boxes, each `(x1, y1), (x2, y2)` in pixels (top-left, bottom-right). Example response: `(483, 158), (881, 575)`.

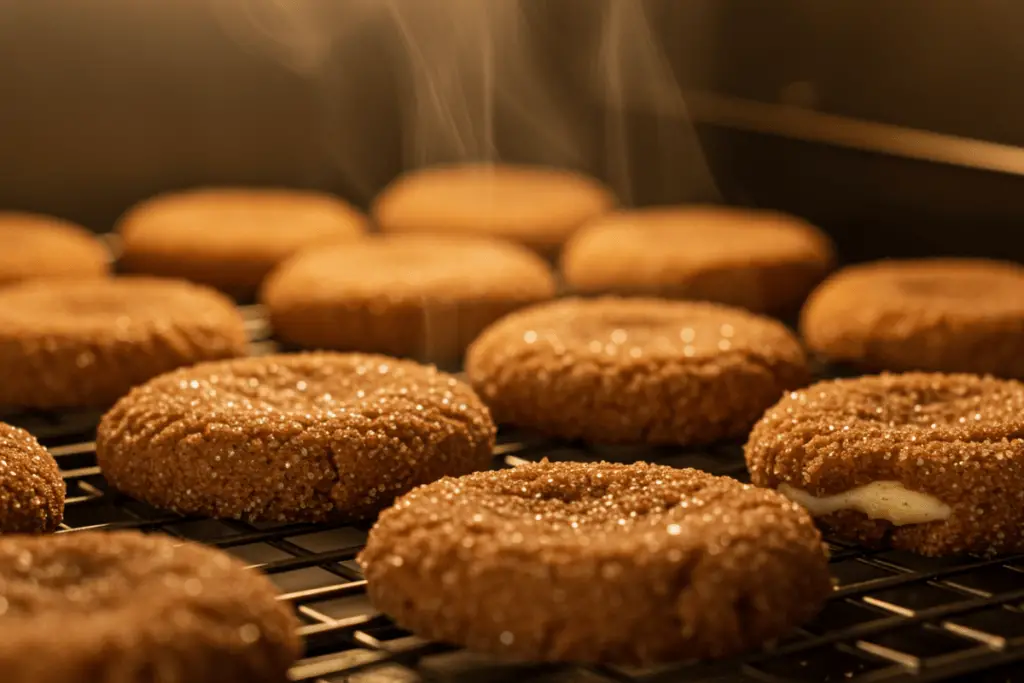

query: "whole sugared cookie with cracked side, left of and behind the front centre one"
(96, 353), (495, 522)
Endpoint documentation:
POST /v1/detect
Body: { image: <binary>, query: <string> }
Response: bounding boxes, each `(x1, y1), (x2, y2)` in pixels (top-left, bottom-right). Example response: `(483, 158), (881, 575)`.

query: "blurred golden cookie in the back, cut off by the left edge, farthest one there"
(0, 212), (111, 285)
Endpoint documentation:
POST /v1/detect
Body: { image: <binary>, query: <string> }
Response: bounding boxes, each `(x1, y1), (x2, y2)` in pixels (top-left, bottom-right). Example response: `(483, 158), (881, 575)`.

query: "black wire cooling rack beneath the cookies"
(6, 311), (1024, 683)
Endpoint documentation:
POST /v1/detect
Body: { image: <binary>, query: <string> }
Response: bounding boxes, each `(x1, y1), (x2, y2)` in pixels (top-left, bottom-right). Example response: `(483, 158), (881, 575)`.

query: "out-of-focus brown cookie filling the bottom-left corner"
(0, 531), (301, 683)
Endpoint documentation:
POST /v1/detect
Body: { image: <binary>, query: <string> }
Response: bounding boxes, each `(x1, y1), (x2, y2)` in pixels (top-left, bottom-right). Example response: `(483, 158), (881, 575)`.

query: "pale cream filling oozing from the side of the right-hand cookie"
(778, 481), (952, 526)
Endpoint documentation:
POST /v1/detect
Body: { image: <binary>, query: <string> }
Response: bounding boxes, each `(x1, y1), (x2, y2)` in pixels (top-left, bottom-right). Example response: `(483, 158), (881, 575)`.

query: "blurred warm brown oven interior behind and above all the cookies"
(0, 0), (1024, 258)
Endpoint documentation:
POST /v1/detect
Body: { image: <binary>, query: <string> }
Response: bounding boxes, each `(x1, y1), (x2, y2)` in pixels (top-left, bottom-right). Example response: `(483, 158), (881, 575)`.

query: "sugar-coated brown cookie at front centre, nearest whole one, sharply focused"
(358, 462), (831, 665)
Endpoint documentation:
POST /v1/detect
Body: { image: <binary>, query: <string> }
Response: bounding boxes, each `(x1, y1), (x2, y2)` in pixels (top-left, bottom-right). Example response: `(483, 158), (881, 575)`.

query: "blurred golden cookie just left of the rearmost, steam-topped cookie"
(117, 187), (367, 299)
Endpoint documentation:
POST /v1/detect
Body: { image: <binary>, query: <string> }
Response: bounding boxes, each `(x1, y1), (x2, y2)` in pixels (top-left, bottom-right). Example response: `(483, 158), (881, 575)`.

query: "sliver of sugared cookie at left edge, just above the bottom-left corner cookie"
(0, 422), (65, 533)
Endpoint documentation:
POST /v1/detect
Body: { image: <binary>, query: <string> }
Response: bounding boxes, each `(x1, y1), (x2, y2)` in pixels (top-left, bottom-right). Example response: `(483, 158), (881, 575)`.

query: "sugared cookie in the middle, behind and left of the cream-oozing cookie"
(466, 298), (810, 444)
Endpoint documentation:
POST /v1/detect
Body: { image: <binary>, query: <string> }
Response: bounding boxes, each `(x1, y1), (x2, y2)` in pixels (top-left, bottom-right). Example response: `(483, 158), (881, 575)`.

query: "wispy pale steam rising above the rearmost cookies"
(210, 0), (716, 202)
